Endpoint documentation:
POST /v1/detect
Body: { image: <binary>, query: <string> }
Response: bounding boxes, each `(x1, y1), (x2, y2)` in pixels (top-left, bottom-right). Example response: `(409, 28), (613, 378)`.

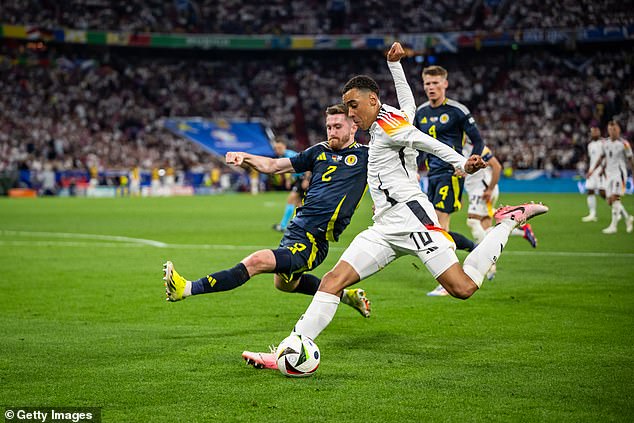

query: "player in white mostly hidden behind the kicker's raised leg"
(462, 143), (537, 280)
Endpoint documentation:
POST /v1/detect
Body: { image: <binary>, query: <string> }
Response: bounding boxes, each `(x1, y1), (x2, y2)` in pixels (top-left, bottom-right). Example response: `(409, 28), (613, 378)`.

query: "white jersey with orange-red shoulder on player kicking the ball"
(368, 104), (466, 230)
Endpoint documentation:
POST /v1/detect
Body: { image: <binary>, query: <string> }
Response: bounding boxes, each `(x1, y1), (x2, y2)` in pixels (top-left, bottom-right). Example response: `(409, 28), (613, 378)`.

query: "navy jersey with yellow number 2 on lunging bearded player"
(290, 142), (368, 241)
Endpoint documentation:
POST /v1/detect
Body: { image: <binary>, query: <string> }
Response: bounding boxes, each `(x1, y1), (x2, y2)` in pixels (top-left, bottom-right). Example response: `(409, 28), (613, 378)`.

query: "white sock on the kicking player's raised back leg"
(462, 219), (515, 288)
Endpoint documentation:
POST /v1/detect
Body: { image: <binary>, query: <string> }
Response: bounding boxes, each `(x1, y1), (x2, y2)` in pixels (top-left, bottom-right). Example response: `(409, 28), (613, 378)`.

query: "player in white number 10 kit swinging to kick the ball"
(278, 43), (548, 346)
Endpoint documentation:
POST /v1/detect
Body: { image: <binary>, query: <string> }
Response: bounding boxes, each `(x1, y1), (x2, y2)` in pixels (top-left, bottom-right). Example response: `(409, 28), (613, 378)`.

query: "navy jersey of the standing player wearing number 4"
(414, 99), (484, 178)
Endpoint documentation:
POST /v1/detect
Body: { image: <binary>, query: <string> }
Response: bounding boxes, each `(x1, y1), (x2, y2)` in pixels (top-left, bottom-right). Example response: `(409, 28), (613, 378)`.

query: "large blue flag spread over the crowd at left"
(164, 118), (275, 157)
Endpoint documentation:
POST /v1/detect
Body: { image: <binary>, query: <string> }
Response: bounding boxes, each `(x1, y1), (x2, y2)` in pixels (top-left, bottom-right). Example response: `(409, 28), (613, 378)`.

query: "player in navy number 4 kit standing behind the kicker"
(414, 66), (484, 296)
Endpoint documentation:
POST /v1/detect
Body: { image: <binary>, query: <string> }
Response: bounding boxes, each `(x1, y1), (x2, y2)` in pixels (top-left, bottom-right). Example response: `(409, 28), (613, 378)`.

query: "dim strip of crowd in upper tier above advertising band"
(0, 0), (634, 34)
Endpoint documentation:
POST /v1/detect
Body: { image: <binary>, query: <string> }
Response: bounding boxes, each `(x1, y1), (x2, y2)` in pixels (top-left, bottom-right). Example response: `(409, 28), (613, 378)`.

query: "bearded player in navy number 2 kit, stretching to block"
(163, 104), (370, 317)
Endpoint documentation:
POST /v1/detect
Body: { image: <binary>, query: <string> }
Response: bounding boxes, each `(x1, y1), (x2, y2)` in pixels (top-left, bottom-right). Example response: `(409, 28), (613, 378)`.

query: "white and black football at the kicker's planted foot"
(275, 334), (321, 377)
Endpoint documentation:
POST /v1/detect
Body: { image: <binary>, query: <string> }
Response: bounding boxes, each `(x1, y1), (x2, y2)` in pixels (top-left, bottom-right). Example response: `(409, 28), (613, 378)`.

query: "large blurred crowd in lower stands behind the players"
(0, 41), (634, 189)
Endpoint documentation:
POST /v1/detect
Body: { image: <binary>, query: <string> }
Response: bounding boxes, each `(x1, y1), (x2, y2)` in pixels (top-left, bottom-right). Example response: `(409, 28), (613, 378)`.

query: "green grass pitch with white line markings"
(0, 193), (634, 422)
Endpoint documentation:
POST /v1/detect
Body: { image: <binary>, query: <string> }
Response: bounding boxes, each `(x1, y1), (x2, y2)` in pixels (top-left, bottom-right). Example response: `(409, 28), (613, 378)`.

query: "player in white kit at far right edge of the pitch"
(588, 120), (634, 234)
